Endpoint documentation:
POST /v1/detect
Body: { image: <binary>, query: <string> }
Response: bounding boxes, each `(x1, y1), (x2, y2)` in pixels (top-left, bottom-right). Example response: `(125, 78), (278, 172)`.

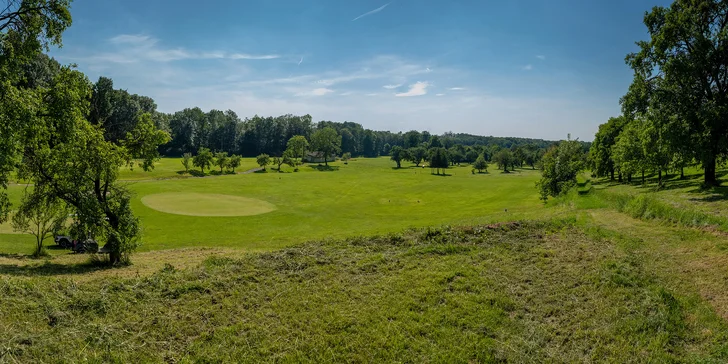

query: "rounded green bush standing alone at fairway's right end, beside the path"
(536, 139), (584, 202)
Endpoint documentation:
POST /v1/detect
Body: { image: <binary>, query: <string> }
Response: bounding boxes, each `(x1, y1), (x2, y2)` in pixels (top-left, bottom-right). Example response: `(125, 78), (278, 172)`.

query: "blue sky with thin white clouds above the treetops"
(51, 0), (669, 140)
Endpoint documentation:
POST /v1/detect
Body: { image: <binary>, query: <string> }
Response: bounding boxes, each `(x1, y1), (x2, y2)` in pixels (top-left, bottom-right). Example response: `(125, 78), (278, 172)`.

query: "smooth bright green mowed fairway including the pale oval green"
(0, 158), (544, 253)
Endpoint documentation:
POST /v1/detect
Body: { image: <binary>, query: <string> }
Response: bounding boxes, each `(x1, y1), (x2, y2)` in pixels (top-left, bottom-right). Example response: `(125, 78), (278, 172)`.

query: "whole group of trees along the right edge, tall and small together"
(589, 0), (728, 186)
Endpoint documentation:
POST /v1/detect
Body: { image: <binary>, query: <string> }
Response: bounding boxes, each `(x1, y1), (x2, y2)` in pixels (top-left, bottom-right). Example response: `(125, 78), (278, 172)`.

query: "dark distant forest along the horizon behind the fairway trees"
(24, 54), (589, 157)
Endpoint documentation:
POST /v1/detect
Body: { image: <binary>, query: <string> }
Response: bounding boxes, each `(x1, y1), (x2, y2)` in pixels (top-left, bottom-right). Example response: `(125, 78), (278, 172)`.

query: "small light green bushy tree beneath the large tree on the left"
(13, 188), (68, 257)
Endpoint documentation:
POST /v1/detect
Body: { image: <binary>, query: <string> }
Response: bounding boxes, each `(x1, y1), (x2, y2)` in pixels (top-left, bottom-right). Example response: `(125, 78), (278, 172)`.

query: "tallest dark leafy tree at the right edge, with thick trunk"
(622, 0), (728, 185)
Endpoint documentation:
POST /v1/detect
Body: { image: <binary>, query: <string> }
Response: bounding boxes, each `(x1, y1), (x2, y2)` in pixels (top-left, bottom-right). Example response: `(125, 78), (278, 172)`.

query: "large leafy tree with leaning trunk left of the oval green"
(18, 67), (168, 264)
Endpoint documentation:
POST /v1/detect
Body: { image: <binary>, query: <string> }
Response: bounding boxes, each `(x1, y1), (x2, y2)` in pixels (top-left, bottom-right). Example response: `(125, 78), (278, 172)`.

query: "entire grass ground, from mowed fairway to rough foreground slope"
(7, 158), (728, 363)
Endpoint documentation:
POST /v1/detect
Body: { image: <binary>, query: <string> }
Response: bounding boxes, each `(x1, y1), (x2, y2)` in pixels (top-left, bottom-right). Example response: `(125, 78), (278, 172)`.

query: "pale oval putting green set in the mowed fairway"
(142, 192), (276, 216)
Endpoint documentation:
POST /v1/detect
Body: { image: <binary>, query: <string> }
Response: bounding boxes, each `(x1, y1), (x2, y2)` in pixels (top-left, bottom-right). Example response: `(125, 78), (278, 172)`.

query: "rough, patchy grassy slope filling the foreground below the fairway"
(0, 219), (728, 363)
